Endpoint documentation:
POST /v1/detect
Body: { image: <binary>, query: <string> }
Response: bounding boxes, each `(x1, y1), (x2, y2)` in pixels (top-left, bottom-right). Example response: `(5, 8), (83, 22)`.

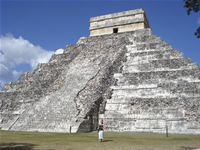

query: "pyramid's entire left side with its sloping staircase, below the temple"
(1, 30), (130, 132)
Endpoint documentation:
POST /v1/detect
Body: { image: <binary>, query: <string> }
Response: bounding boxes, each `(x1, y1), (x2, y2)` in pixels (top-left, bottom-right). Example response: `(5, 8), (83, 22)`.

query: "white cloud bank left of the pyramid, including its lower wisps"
(0, 34), (64, 90)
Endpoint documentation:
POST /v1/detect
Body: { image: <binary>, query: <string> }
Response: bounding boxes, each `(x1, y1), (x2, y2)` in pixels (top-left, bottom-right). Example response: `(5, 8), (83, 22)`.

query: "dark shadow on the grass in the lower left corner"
(0, 143), (36, 150)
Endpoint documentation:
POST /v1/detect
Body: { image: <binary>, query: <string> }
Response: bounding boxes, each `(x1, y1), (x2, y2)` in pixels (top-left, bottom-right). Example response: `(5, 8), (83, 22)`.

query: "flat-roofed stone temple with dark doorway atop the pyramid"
(90, 8), (151, 36)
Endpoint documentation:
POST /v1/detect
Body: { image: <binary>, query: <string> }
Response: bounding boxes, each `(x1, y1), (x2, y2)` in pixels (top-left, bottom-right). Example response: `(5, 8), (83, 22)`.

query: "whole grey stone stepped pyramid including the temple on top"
(0, 9), (200, 134)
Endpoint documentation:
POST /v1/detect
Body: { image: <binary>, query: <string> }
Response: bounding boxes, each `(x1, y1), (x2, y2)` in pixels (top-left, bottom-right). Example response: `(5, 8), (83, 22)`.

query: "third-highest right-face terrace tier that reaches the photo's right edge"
(105, 94), (200, 111)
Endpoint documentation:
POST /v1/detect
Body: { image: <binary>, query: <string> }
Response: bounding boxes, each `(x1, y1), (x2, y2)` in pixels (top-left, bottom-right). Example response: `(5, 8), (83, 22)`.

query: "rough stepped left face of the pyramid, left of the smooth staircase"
(0, 45), (82, 129)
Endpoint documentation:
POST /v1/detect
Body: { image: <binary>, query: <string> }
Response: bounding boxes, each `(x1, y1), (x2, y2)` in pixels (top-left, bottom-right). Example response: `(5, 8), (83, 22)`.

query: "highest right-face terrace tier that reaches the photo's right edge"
(114, 69), (200, 85)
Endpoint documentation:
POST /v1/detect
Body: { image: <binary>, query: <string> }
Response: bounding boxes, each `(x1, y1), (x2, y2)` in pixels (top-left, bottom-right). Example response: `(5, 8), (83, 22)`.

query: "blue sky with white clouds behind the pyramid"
(0, 0), (200, 90)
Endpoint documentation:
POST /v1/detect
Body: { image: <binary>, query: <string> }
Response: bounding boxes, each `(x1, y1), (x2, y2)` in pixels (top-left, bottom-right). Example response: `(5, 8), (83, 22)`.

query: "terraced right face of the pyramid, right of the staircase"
(99, 30), (200, 134)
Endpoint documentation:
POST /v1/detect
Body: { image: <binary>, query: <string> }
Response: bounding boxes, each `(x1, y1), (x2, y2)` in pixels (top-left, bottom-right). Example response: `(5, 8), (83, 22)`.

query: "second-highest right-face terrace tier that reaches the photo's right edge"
(112, 82), (200, 97)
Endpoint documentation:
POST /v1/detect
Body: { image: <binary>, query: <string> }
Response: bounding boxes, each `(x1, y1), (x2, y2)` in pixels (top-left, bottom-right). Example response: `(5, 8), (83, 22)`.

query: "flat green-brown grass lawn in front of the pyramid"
(0, 131), (200, 150)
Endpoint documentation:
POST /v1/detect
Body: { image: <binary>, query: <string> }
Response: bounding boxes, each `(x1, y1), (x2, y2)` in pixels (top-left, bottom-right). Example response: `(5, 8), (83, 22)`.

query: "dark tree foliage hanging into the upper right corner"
(183, 0), (200, 38)
